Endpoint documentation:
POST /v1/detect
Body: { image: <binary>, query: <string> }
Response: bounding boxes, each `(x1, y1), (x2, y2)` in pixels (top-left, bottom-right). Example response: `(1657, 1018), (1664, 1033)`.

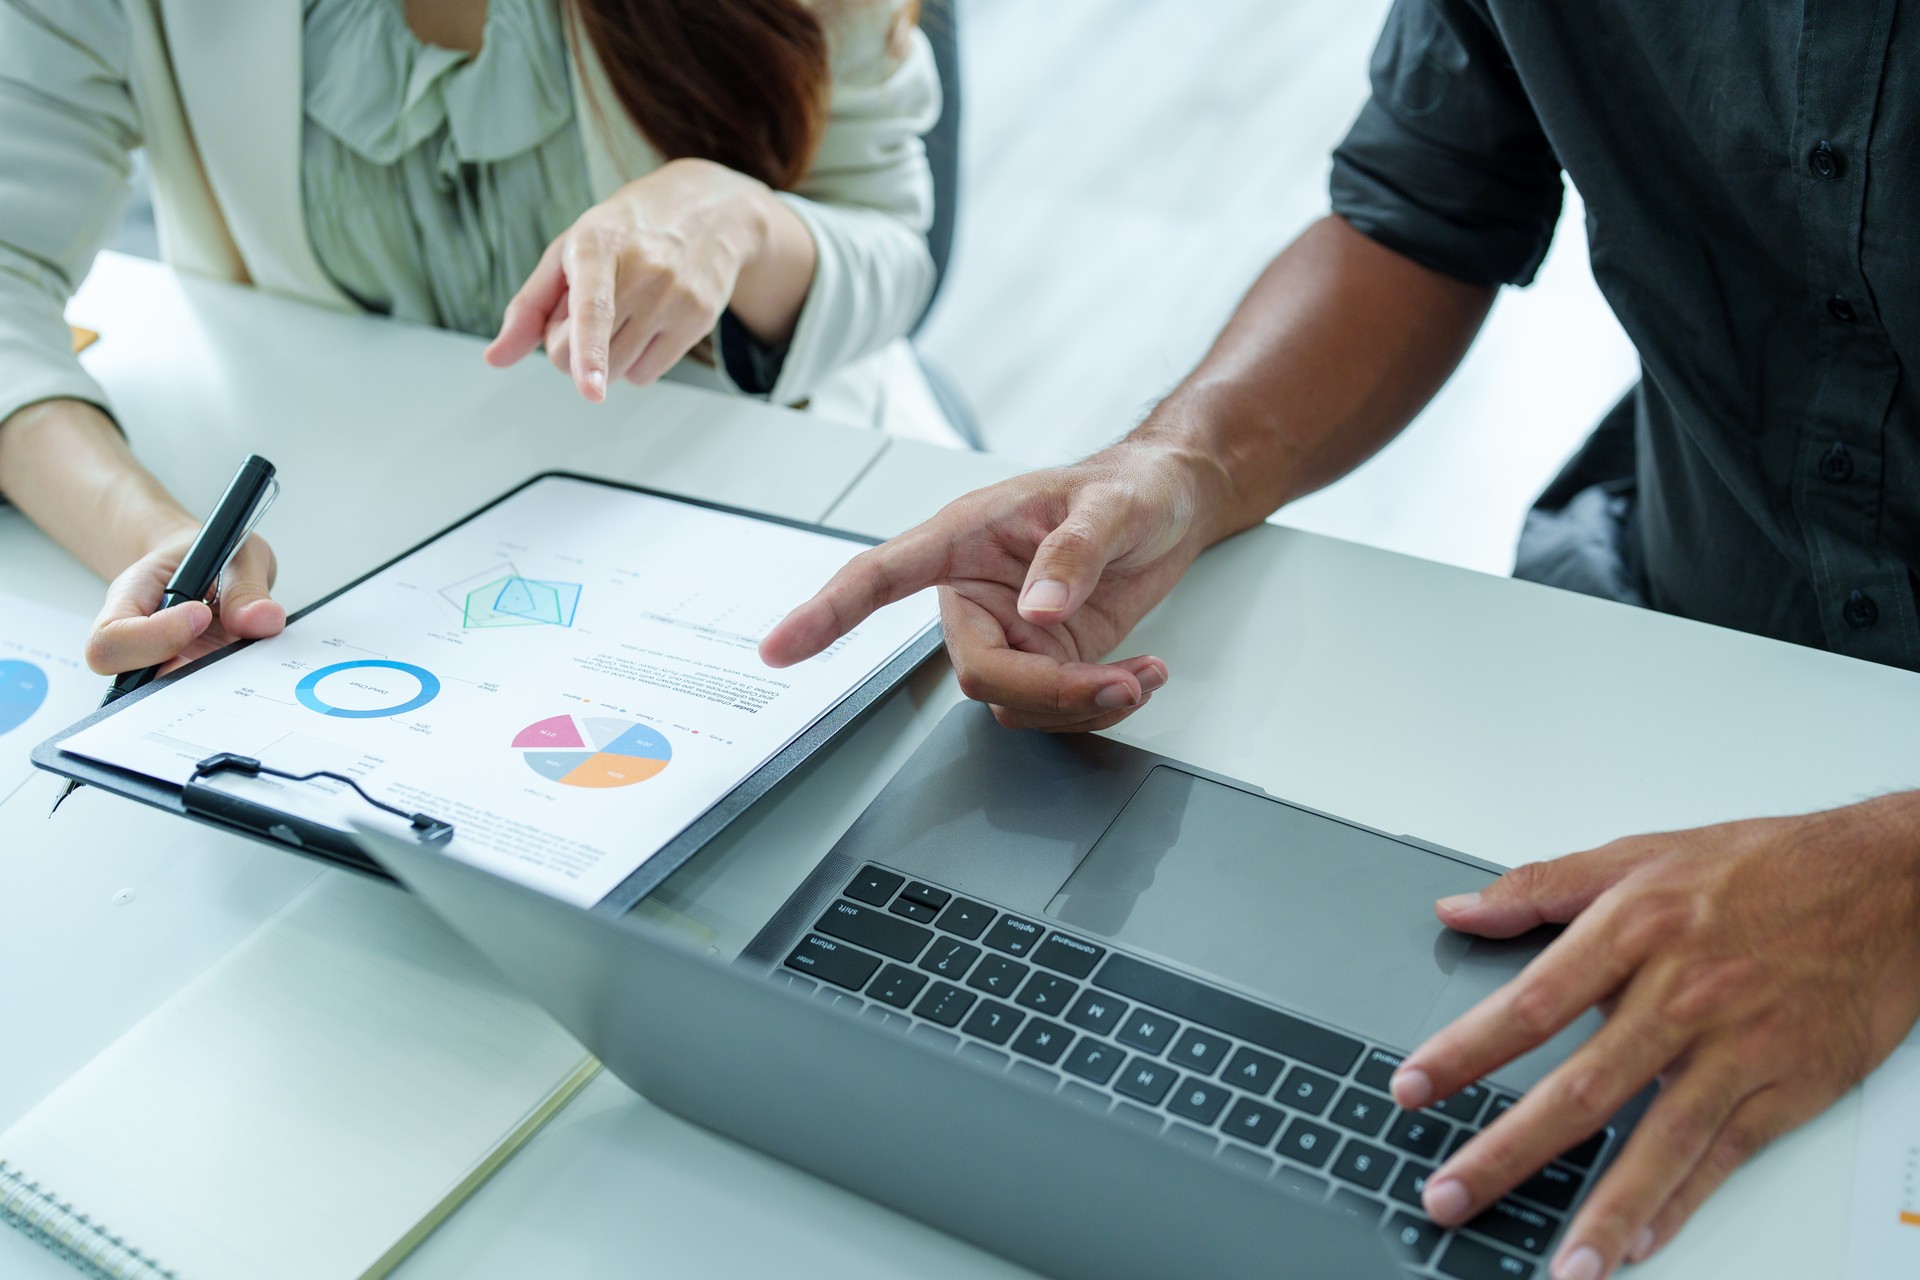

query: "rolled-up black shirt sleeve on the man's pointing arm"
(1331, 0), (1561, 286)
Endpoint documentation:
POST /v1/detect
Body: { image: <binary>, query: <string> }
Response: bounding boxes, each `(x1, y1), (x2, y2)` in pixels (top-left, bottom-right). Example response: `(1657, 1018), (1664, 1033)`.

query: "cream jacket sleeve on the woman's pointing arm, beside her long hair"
(752, 6), (941, 405)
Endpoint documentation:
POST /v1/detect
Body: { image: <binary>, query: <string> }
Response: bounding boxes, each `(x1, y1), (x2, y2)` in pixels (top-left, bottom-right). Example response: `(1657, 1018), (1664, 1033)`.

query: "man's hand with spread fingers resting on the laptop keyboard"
(1394, 793), (1920, 1280)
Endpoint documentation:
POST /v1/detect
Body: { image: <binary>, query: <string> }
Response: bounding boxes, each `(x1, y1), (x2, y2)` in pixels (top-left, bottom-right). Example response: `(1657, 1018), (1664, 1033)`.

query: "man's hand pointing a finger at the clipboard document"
(760, 443), (1217, 731)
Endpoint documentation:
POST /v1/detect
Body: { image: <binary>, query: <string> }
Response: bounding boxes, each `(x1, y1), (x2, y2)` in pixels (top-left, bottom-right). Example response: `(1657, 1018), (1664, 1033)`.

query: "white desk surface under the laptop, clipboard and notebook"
(0, 263), (1920, 1280)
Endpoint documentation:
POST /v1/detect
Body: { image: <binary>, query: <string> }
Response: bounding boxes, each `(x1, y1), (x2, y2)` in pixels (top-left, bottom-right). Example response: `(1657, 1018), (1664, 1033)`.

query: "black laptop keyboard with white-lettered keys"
(776, 864), (1615, 1280)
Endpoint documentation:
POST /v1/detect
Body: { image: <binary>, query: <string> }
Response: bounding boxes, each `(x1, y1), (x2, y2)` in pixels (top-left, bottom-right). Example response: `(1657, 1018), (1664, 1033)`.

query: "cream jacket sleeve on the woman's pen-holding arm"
(0, 0), (140, 422)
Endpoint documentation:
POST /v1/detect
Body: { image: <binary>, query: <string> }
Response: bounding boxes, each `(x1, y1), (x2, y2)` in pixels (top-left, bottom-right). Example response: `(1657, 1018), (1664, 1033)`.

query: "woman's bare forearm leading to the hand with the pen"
(0, 399), (194, 578)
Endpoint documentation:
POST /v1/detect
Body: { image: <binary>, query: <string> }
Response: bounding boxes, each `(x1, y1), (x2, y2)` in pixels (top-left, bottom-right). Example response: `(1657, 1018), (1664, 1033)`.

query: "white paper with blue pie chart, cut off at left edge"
(0, 595), (94, 800)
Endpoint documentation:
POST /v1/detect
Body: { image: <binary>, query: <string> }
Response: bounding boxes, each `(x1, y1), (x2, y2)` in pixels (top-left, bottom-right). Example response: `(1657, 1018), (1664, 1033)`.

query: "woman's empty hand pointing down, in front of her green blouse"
(486, 159), (816, 403)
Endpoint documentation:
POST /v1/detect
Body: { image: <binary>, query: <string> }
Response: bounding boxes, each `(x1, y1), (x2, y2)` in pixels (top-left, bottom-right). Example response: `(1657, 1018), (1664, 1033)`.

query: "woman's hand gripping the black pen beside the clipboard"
(86, 525), (286, 676)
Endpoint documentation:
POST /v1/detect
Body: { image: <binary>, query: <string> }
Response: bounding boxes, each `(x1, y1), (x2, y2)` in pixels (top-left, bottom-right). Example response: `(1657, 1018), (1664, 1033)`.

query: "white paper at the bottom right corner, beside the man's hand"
(1847, 1036), (1920, 1280)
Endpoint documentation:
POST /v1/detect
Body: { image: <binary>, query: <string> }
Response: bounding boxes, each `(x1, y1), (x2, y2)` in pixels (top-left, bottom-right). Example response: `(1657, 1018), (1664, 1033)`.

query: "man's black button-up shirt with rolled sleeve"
(1332, 0), (1920, 670)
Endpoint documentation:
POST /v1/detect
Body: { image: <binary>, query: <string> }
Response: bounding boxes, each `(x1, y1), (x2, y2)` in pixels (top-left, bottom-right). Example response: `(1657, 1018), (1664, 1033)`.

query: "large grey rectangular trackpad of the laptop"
(1046, 766), (1515, 1074)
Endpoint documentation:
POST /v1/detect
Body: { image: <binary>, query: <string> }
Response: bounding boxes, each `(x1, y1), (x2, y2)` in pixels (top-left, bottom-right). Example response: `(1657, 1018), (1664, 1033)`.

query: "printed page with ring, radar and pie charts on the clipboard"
(63, 476), (937, 906)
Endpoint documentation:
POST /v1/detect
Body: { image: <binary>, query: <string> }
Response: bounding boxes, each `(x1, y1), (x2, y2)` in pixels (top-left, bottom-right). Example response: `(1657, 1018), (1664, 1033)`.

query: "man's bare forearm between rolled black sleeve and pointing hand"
(1129, 217), (1494, 541)
